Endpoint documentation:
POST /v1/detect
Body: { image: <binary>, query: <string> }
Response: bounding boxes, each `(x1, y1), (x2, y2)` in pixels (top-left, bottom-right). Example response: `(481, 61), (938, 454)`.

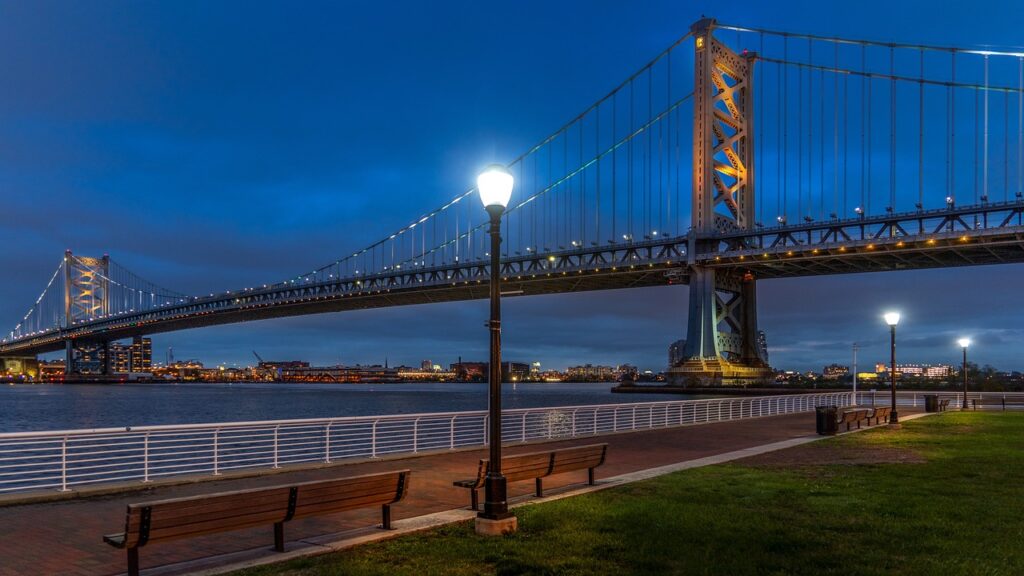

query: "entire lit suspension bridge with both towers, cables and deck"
(0, 18), (1024, 382)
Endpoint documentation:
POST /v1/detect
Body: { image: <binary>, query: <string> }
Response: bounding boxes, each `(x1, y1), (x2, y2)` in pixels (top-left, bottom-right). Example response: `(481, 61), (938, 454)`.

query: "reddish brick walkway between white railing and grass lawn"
(0, 413), (814, 576)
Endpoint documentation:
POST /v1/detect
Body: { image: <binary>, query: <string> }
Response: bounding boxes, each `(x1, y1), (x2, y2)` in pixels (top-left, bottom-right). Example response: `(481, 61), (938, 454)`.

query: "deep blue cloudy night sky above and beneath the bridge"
(0, 0), (1024, 370)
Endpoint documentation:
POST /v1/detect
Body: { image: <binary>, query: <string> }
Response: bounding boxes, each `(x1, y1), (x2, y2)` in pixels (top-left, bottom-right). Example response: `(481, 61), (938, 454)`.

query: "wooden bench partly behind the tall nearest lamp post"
(452, 444), (608, 510)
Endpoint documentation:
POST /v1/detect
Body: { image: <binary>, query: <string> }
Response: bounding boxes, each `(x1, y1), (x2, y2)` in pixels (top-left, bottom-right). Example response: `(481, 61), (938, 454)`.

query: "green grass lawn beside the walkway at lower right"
(237, 412), (1024, 576)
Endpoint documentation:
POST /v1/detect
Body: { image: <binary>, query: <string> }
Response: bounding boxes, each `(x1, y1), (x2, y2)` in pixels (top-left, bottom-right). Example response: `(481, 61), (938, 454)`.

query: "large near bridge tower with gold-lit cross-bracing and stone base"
(669, 18), (771, 385)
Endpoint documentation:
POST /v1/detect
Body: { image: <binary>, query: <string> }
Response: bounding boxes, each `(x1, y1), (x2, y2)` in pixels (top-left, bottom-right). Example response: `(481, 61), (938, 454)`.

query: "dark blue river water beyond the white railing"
(0, 382), (696, 433)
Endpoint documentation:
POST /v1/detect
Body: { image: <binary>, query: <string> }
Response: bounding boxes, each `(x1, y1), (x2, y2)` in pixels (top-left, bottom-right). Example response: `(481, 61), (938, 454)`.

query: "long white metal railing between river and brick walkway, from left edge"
(0, 393), (852, 493)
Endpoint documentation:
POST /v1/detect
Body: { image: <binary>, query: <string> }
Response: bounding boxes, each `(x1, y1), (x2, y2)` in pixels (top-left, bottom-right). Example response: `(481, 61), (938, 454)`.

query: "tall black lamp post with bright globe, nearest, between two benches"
(476, 164), (516, 536)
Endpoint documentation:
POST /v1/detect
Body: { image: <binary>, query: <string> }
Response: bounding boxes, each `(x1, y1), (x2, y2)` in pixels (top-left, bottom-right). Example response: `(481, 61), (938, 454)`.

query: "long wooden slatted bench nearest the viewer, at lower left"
(103, 469), (410, 576)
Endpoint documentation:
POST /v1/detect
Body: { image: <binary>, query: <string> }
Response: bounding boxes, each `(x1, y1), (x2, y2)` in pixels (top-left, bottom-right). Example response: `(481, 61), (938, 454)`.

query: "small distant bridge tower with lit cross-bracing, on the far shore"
(65, 250), (111, 374)
